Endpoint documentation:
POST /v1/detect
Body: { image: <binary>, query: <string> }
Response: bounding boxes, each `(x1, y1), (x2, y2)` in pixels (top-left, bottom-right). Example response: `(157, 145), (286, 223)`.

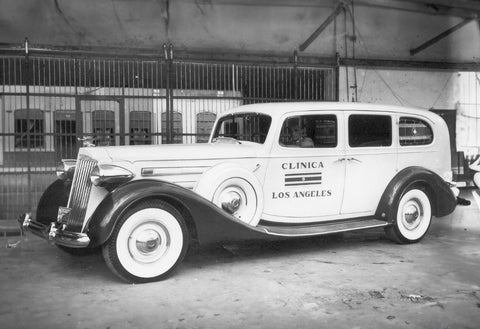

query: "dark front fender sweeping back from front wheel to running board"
(87, 180), (270, 247)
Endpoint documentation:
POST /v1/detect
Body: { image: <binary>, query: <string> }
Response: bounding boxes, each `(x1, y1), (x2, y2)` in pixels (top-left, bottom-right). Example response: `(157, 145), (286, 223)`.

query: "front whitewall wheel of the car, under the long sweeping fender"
(102, 200), (188, 283)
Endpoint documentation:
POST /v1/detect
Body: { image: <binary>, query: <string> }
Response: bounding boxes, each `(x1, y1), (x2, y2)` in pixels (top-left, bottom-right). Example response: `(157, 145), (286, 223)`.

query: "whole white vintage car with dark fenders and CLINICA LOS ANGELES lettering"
(21, 102), (456, 282)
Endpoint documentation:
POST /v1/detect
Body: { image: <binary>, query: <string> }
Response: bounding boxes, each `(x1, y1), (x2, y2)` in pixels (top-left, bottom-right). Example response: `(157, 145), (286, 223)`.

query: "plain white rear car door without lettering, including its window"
(341, 112), (398, 217)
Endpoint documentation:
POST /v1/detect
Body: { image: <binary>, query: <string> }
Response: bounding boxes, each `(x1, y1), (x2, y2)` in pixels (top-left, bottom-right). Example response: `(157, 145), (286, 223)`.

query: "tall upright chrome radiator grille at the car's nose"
(67, 157), (97, 229)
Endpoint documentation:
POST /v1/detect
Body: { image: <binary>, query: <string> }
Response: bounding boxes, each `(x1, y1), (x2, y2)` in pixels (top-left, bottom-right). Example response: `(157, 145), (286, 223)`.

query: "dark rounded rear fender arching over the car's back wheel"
(375, 167), (457, 223)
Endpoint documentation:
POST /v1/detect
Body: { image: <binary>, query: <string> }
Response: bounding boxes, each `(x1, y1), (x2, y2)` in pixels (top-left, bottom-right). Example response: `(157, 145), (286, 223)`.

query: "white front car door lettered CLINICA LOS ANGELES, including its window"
(263, 111), (345, 223)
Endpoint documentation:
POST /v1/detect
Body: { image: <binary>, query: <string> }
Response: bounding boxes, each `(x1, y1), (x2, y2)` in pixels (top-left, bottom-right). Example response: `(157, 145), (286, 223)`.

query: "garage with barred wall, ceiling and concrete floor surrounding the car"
(0, 0), (480, 328)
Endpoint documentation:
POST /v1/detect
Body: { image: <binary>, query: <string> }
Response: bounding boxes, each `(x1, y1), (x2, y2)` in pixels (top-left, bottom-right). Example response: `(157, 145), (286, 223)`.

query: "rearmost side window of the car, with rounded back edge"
(399, 117), (433, 146)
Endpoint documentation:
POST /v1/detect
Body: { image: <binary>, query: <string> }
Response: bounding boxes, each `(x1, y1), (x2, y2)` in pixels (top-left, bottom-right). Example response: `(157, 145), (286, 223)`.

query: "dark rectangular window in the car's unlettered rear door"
(348, 114), (392, 147)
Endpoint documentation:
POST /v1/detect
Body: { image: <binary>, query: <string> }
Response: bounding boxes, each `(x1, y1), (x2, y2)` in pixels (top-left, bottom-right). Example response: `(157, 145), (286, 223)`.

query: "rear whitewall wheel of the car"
(385, 189), (432, 244)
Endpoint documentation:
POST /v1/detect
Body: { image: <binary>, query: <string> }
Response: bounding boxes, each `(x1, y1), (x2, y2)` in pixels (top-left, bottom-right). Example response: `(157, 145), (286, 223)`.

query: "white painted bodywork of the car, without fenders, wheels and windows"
(80, 103), (451, 226)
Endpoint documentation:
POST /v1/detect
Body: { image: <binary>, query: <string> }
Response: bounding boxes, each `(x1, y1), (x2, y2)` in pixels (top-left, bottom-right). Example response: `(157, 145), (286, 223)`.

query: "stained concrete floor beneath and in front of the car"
(0, 190), (480, 329)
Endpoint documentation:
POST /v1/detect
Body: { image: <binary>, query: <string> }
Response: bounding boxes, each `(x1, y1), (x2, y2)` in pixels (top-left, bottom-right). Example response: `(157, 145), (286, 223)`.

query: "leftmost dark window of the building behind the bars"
(14, 109), (45, 148)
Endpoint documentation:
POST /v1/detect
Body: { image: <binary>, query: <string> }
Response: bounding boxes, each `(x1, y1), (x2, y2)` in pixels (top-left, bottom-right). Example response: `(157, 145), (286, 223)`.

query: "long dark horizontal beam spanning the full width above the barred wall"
(0, 43), (480, 71)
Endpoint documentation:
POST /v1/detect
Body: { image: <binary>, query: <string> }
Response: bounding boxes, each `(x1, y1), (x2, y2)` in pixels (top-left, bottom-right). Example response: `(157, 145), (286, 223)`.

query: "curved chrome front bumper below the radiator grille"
(18, 213), (90, 248)
